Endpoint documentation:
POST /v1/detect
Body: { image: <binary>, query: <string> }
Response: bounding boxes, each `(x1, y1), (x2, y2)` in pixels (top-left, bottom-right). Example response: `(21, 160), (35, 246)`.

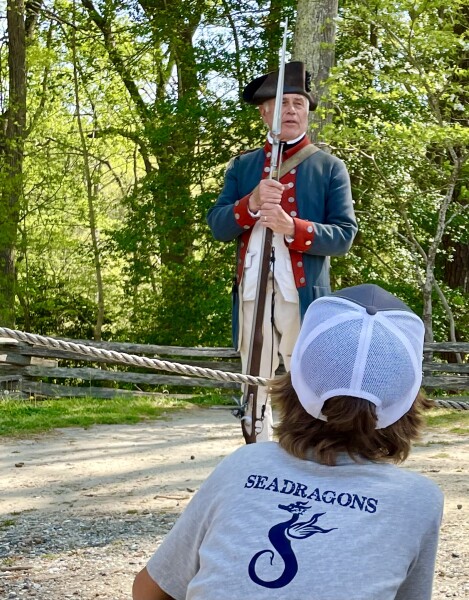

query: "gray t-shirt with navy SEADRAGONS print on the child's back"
(147, 442), (443, 600)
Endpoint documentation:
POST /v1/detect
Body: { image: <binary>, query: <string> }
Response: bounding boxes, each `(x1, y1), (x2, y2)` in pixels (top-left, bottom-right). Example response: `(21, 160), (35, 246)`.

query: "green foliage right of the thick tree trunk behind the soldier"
(322, 0), (469, 339)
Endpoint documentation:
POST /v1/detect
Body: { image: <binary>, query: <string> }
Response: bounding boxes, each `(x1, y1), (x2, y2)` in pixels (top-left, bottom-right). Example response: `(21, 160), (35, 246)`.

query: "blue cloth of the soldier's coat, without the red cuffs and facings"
(207, 148), (358, 348)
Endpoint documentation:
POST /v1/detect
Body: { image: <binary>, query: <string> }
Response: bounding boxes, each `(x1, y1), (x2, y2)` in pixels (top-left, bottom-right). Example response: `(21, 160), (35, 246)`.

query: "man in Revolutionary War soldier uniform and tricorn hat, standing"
(207, 62), (357, 441)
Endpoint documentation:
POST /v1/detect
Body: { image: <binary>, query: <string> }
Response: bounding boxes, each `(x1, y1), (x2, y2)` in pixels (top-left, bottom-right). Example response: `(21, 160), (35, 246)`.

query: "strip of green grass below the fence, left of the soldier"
(0, 394), (233, 437)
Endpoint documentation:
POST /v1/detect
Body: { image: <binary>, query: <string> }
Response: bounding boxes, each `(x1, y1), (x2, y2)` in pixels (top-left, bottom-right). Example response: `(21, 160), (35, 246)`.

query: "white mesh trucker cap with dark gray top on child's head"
(290, 284), (424, 429)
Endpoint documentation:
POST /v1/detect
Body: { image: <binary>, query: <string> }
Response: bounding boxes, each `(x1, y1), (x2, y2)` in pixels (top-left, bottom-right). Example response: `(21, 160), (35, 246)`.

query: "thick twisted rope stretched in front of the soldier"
(0, 327), (469, 410)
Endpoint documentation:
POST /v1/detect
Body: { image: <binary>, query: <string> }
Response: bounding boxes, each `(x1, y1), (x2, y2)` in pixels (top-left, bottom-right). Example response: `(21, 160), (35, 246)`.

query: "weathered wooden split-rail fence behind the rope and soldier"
(0, 330), (469, 406)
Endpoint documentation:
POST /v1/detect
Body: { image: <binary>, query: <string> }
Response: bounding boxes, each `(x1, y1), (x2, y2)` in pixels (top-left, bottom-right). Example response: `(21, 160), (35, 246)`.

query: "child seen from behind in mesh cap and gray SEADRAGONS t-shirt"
(133, 284), (443, 600)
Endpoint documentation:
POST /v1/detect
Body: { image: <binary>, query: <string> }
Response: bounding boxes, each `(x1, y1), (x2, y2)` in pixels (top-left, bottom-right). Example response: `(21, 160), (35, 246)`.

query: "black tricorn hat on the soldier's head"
(243, 61), (318, 110)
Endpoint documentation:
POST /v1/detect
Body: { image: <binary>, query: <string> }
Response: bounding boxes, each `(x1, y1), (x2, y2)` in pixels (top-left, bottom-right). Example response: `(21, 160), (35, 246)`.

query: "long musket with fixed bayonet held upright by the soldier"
(241, 19), (288, 444)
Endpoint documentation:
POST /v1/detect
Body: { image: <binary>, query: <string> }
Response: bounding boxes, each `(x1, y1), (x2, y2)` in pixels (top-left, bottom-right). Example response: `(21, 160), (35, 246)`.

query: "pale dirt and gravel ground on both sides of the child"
(0, 408), (469, 600)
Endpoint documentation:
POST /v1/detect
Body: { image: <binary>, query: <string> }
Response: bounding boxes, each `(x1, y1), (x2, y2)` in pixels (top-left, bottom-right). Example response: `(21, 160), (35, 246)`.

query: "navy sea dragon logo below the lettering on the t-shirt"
(249, 502), (337, 588)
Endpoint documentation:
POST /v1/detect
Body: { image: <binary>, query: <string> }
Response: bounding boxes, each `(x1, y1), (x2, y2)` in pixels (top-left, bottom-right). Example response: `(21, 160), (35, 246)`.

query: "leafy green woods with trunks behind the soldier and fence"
(0, 0), (469, 346)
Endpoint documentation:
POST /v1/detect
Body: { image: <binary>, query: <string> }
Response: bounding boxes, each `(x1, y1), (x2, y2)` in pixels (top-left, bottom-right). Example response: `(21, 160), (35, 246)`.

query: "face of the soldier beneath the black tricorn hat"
(259, 94), (309, 142)
